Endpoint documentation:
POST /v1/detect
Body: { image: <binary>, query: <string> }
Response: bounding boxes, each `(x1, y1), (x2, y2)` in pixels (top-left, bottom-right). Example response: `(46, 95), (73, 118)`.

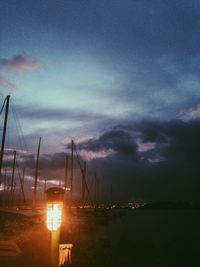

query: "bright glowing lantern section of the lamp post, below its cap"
(46, 203), (63, 231)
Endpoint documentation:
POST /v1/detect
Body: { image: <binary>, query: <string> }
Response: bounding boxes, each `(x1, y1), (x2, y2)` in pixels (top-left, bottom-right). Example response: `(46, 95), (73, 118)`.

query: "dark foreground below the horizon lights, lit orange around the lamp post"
(0, 210), (200, 267)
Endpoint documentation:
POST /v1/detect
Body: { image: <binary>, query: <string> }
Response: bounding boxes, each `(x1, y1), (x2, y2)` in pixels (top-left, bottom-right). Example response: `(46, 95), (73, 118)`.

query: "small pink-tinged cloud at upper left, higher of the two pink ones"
(0, 55), (40, 72)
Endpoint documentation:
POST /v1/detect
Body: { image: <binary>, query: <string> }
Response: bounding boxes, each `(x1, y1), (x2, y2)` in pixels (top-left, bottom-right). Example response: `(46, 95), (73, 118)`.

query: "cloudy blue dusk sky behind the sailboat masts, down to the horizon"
(0, 0), (200, 201)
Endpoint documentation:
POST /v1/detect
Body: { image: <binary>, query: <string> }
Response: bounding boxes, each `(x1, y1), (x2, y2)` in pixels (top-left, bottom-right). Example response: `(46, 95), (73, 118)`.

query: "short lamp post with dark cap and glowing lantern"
(46, 187), (65, 267)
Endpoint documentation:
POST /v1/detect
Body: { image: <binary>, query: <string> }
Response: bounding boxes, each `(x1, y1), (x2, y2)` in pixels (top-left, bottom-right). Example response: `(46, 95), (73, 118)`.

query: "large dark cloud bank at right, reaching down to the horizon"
(70, 120), (200, 200)
